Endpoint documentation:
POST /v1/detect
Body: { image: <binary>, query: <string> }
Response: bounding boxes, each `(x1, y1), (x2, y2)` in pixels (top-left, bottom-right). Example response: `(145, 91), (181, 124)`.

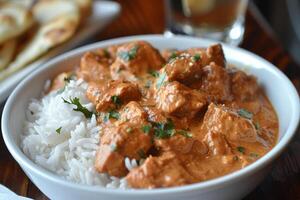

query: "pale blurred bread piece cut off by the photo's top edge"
(32, 0), (80, 24)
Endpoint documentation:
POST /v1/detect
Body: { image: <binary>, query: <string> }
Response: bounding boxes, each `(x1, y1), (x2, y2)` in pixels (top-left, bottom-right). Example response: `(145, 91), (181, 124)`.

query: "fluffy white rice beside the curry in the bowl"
(21, 80), (138, 189)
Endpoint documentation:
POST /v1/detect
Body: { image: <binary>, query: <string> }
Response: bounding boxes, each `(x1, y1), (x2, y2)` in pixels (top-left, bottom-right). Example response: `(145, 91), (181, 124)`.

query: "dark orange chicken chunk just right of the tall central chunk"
(191, 63), (232, 102)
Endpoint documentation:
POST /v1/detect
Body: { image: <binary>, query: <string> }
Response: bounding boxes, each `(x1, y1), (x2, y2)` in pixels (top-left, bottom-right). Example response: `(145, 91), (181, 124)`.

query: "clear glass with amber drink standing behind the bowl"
(165, 0), (248, 46)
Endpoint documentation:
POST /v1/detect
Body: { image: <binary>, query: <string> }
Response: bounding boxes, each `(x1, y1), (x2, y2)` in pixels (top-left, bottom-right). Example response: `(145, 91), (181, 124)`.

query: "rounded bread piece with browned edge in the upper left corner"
(0, 2), (34, 44)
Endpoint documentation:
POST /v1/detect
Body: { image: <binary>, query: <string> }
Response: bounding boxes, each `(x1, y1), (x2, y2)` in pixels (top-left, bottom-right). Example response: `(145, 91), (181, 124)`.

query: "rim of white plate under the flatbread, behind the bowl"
(0, 1), (121, 103)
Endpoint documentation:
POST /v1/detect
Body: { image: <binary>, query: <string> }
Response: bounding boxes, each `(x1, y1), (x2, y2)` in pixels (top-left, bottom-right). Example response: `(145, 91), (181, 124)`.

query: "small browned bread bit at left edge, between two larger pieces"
(0, 39), (17, 70)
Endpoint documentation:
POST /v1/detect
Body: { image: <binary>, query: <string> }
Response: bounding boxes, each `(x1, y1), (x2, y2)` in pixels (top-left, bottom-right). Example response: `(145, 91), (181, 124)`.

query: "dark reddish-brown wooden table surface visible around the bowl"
(0, 0), (300, 200)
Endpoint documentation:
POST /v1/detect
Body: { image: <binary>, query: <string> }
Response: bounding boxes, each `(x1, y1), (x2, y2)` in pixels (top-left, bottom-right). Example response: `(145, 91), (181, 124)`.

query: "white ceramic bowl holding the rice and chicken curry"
(2, 35), (300, 200)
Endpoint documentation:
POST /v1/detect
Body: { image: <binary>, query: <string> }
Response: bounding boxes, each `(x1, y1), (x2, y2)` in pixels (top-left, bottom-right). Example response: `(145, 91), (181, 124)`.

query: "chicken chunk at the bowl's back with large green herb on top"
(110, 41), (164, 80)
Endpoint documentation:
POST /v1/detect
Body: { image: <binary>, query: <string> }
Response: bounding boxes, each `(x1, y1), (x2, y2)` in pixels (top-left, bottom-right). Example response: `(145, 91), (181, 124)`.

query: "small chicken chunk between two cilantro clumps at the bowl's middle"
(120, 101), (148, 125)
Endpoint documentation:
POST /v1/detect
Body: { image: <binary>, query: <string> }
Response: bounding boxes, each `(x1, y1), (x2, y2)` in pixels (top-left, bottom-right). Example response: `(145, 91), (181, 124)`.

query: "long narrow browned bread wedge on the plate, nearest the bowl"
(0, 12), (80, 81)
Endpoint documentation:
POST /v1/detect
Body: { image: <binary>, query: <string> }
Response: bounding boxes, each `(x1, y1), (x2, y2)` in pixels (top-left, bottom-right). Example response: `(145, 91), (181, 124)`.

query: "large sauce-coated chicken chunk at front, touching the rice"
(95, 122), (152, 177)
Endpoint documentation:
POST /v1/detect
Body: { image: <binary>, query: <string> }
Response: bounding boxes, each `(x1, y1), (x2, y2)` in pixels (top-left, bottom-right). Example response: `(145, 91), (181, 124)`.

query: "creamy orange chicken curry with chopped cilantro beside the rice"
(51, 41), (279, 189)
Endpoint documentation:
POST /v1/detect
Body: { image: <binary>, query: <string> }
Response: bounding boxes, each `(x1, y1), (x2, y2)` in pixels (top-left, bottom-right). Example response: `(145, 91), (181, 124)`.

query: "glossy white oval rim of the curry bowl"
(1, 34), (300, 196)
